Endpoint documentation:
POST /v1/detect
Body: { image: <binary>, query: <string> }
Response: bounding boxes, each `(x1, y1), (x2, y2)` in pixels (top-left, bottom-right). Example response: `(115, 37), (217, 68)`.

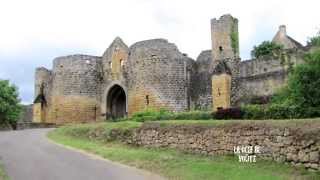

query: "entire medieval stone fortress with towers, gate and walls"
(33, 15), (316, 124)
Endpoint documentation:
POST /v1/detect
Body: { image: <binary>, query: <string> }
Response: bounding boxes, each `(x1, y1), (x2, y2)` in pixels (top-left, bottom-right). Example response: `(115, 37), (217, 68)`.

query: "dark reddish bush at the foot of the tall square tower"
(213, 108), (243, 119)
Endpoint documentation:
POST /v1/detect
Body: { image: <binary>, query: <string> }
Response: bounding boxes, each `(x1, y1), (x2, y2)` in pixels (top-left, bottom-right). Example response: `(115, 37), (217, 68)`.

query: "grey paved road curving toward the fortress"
(0, 129), (165, 180)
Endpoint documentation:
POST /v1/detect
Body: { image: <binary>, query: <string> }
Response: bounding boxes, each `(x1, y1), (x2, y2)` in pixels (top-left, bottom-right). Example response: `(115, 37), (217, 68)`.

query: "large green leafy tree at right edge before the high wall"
(273, 50), (320, 116)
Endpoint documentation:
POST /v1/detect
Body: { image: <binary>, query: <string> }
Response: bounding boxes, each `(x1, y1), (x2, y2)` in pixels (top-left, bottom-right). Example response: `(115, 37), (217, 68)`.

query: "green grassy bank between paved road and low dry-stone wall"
(48, 121), (320, 180)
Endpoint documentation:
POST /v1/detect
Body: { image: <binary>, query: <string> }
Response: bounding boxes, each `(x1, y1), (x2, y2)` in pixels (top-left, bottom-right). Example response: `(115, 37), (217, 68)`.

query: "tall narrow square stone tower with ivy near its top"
(211, 14), (240, 111)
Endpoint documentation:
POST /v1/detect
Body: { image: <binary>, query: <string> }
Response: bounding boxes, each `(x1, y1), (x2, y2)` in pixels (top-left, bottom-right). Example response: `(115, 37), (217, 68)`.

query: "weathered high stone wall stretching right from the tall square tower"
(236, 49), (305, 105)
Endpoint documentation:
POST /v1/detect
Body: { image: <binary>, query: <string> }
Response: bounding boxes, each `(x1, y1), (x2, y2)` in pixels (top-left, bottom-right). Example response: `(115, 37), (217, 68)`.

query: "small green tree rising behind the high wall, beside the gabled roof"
(251, 41), (283, 58)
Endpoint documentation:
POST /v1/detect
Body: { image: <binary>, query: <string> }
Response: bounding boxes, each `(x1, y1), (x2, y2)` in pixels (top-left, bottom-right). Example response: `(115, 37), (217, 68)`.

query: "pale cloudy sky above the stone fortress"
(0, 0), (320, 103)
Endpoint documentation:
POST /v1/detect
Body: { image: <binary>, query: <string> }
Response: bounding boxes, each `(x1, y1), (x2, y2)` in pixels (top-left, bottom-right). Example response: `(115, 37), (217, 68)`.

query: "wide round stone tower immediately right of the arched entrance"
(127, 39), (190, 115)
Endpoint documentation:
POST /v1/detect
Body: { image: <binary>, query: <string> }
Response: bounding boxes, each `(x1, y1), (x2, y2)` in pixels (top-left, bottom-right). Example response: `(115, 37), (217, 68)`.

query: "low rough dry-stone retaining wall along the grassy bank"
(112, 122), (320, 170)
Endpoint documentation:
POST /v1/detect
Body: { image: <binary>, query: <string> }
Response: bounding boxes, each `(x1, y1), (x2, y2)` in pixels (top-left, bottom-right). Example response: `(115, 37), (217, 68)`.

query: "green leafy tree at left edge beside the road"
(0, 80), (21, 126)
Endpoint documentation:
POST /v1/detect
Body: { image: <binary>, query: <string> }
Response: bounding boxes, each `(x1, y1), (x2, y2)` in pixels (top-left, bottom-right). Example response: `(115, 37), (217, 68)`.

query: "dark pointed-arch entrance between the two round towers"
(107, 85), (126, 119)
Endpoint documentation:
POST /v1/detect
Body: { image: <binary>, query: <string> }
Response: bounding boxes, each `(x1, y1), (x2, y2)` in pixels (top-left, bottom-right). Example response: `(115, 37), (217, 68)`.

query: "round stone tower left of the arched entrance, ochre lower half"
(48, 55), (102, 124)
